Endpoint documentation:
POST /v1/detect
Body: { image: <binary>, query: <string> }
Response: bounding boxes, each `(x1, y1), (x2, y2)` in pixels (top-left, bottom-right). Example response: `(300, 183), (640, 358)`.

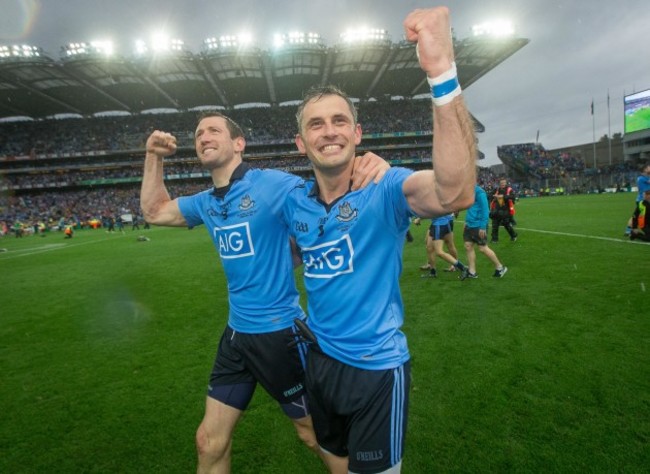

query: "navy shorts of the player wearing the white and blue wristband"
(307, 350), (411, 473)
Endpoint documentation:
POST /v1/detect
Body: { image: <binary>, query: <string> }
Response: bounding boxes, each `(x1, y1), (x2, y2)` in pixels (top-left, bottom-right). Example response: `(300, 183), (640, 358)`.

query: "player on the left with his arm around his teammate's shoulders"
(140, 113), (388, 473)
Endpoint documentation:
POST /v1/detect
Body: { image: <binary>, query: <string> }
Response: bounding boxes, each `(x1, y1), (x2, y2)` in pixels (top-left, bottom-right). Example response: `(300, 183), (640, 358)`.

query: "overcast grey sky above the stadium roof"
(0, 0), (650, 166)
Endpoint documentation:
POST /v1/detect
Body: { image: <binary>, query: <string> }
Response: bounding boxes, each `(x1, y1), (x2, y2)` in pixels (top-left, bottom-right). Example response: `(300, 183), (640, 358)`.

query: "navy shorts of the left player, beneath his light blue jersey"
(208, 326), (309, 418)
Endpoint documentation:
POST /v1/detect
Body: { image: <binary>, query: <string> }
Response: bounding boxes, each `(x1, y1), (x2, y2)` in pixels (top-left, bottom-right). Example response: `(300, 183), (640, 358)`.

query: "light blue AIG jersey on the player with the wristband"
(285, 168), (413, 370)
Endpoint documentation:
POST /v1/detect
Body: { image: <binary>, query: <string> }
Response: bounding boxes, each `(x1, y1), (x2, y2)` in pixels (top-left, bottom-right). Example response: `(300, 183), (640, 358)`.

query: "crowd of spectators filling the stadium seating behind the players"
(0, 99), (635, 233)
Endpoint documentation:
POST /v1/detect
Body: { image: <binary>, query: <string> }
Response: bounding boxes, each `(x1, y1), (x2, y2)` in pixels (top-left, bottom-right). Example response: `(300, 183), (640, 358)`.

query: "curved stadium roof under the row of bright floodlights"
(0, 37), (529, 119)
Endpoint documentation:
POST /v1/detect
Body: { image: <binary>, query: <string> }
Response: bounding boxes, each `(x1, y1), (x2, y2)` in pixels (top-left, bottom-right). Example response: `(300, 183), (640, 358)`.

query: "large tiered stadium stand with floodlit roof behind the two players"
(0, 30), (528, 232)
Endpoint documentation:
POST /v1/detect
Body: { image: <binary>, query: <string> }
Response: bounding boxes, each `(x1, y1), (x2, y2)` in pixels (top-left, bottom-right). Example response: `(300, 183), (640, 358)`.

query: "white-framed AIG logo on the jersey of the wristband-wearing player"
(302, 234), (354, 278)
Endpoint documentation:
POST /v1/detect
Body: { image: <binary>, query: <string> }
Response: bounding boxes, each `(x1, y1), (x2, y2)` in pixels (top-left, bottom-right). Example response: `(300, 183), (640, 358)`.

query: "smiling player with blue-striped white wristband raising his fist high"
(284, 7), (476, 473)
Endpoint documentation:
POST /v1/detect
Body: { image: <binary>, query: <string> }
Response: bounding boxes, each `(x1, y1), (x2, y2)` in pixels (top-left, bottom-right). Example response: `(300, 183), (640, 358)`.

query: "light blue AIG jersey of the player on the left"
(178, 165), (304, 333)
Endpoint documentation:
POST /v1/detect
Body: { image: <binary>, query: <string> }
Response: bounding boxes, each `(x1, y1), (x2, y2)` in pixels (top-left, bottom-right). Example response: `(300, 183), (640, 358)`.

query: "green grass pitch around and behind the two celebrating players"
(0, 193), (650, 474)
